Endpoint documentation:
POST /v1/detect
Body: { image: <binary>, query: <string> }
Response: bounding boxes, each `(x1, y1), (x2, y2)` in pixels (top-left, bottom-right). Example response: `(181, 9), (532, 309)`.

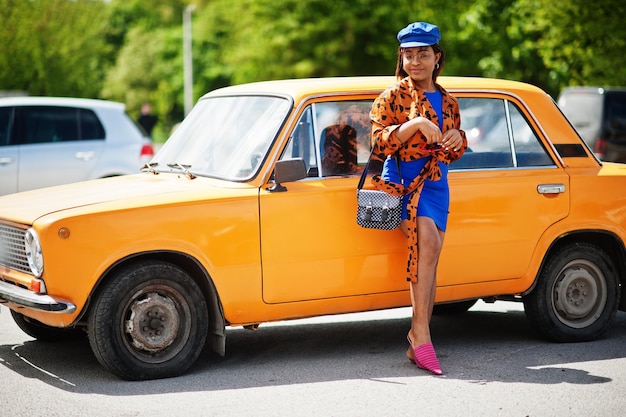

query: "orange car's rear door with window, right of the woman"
(438, 93), (569, 291)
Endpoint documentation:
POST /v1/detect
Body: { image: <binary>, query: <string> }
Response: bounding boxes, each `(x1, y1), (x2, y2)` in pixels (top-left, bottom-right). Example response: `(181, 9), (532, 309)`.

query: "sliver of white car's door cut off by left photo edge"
(0, 107), (19, 195)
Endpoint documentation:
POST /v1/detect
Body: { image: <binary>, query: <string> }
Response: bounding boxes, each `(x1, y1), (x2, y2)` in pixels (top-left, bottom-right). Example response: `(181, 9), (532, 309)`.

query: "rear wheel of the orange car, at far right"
(523, 243), (620, 342)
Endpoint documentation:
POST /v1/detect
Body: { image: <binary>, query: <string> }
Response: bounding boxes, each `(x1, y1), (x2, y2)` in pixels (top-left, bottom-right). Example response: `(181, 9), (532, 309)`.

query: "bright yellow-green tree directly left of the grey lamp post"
(102, 0), (187, 141)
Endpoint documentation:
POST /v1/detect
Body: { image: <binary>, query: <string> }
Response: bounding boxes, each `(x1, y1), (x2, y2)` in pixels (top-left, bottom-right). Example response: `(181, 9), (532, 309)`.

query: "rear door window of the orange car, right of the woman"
(450, 98), (553, 169)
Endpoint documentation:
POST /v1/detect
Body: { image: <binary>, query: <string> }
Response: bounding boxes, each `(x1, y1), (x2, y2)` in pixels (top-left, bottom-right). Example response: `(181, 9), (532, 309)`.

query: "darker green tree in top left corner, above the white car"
(0, 0), (107, 97)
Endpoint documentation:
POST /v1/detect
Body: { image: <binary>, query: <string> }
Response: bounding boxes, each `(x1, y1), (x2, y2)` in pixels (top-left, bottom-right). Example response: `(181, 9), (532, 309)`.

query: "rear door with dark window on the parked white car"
(18, 106), (104, 191)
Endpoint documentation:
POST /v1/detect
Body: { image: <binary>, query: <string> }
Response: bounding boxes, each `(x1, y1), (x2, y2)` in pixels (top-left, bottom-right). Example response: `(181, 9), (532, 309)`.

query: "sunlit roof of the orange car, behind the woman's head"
(204, 76), (542, 98)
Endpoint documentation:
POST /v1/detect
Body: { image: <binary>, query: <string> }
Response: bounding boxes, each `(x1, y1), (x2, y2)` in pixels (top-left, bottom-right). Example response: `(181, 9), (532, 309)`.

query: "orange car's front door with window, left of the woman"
(260, 99), (407, 303)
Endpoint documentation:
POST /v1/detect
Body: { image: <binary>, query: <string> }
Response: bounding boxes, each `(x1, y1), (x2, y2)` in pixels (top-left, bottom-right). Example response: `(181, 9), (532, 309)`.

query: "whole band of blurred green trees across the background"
(0, 0), (626, 139)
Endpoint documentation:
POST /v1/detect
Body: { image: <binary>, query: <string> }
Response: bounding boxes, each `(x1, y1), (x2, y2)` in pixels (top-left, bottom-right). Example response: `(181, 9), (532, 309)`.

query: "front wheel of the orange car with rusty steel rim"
(88, 262), (209, 380)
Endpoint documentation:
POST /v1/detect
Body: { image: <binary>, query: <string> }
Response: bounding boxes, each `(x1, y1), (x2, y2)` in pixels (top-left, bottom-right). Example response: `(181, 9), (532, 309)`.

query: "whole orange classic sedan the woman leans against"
(0, 77), (626, 380)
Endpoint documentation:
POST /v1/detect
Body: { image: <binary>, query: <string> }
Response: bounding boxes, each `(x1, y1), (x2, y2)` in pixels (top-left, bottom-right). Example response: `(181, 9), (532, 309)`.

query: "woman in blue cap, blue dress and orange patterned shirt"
(370, 22), (467, 375)
